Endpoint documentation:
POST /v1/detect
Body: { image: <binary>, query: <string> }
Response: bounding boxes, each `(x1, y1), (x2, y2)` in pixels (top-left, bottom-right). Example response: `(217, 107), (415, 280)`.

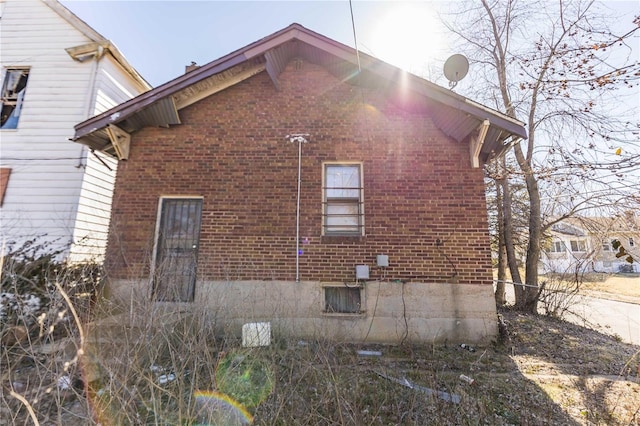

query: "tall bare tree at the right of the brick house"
(442, 0), (640, 312)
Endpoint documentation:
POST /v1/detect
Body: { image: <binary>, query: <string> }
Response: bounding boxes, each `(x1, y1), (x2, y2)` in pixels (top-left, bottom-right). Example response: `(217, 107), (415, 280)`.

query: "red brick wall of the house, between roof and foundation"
(108, 63), (491, 284)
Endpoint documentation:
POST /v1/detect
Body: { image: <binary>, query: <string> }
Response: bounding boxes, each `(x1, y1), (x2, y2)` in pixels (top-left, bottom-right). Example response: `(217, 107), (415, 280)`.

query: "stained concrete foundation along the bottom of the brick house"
(108, 280), (497, 344)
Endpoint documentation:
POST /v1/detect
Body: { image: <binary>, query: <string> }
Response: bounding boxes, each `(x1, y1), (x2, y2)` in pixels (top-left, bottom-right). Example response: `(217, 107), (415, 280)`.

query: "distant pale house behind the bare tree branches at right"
(539, 212), (640, 273)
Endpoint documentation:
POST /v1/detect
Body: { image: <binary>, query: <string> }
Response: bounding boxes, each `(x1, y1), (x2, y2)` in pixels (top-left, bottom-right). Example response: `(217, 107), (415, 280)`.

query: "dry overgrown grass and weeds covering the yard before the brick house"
(0, 296), (640, 426)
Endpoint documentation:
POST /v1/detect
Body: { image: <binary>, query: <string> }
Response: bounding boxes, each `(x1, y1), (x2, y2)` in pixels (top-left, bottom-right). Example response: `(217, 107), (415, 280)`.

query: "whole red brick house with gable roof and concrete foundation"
(75, 24), (526, 342)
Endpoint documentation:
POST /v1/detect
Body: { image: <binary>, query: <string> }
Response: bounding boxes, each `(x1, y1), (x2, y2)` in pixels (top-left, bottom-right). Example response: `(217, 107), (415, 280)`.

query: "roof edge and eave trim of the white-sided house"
(42, 0), (151, 89)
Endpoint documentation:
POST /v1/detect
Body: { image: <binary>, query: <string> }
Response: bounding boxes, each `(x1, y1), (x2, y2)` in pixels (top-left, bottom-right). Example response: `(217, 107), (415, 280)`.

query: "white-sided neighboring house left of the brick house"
(0, 0), (151, 261)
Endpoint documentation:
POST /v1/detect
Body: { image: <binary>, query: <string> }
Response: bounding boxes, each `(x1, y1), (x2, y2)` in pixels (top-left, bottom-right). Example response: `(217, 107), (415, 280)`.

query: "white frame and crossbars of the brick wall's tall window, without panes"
(322, 161), (365, 237)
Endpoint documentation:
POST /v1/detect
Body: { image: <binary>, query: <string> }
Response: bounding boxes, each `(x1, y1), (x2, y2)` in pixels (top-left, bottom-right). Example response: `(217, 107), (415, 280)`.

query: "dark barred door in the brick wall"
(153, 198), (202, 302)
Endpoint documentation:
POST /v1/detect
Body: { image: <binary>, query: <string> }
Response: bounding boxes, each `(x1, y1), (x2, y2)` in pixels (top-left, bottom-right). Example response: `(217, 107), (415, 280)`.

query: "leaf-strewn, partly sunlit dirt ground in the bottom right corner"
(504, 312), (640, 425)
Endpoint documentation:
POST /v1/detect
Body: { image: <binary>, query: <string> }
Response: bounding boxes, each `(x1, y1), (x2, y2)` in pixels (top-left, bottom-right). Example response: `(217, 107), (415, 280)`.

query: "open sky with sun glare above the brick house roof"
(61, 0), (476, 86)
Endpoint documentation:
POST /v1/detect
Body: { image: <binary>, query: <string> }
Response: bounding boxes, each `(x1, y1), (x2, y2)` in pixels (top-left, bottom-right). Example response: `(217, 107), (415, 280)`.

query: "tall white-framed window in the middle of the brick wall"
(323, 163), (364, 235)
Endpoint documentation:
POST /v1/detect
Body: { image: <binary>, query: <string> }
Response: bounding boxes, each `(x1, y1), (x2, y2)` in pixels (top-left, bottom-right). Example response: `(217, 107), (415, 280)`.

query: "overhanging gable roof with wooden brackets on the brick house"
(73, 23), (527, 161)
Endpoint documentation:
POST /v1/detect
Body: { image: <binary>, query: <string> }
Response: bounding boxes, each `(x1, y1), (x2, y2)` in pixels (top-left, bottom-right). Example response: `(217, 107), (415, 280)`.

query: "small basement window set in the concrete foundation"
(322, 283), (366, 317)
